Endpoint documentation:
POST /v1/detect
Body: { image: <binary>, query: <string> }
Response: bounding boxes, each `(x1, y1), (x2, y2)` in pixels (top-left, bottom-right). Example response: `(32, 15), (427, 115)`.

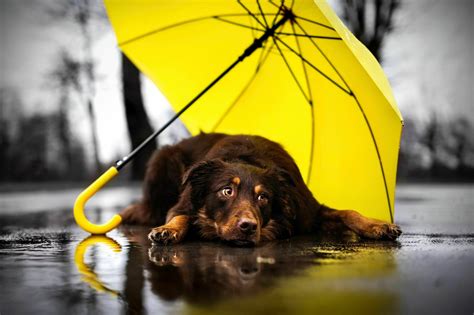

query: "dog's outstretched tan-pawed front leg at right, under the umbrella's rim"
(319, 206), (402, 240)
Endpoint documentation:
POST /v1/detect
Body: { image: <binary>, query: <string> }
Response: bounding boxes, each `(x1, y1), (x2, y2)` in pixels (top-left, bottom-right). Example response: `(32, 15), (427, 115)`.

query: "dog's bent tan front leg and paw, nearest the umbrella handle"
(148, 187), (192, 245)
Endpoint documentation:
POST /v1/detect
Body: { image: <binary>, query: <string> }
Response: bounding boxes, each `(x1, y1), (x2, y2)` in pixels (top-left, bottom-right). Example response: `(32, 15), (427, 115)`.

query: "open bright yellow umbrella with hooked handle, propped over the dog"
(72, 0), (402, 233)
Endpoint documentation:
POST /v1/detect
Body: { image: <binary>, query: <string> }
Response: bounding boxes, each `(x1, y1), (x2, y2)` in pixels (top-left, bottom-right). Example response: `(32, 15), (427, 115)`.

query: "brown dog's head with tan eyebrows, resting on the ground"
(183, 159), (292, 246)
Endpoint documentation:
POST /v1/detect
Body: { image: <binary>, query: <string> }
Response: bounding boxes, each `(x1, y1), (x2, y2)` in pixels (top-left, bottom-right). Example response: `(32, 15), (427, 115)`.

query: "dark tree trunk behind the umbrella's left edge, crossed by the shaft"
(122, 53), (157, 180)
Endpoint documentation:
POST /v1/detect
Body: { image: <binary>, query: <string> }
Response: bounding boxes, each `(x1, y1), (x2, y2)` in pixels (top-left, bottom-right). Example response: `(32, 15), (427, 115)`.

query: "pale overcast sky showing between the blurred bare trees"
(0, 0), (474, 161)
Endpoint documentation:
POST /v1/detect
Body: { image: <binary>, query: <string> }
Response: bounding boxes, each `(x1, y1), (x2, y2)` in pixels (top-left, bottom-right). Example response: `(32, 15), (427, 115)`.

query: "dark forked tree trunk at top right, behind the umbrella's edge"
(341, 0), (401, 61)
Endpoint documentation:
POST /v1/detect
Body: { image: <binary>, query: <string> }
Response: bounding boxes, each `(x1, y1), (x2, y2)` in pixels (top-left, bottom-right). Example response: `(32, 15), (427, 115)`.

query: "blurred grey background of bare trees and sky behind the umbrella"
(0, 0), (474, 190)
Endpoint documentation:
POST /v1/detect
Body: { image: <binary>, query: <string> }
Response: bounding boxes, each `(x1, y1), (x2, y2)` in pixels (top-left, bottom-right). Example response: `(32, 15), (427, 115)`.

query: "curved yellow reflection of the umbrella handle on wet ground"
(74, 235), (122, 297)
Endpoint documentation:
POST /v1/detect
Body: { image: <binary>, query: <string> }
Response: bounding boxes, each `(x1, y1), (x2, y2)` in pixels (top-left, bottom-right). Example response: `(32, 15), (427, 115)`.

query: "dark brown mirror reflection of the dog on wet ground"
(148, 243), (310, 302)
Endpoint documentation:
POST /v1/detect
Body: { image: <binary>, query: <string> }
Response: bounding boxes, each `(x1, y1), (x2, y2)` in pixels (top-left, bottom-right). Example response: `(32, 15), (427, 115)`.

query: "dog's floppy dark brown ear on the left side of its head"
(183, 159), (226, 204)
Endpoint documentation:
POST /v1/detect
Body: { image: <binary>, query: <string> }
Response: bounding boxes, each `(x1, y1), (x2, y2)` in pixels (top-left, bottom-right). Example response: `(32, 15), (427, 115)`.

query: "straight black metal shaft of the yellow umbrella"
(115, 10), (293, 170)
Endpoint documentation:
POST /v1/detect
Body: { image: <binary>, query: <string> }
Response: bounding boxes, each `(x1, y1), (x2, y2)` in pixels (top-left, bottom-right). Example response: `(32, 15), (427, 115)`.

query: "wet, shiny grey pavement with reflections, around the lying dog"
(0, 185), (474, 315)
